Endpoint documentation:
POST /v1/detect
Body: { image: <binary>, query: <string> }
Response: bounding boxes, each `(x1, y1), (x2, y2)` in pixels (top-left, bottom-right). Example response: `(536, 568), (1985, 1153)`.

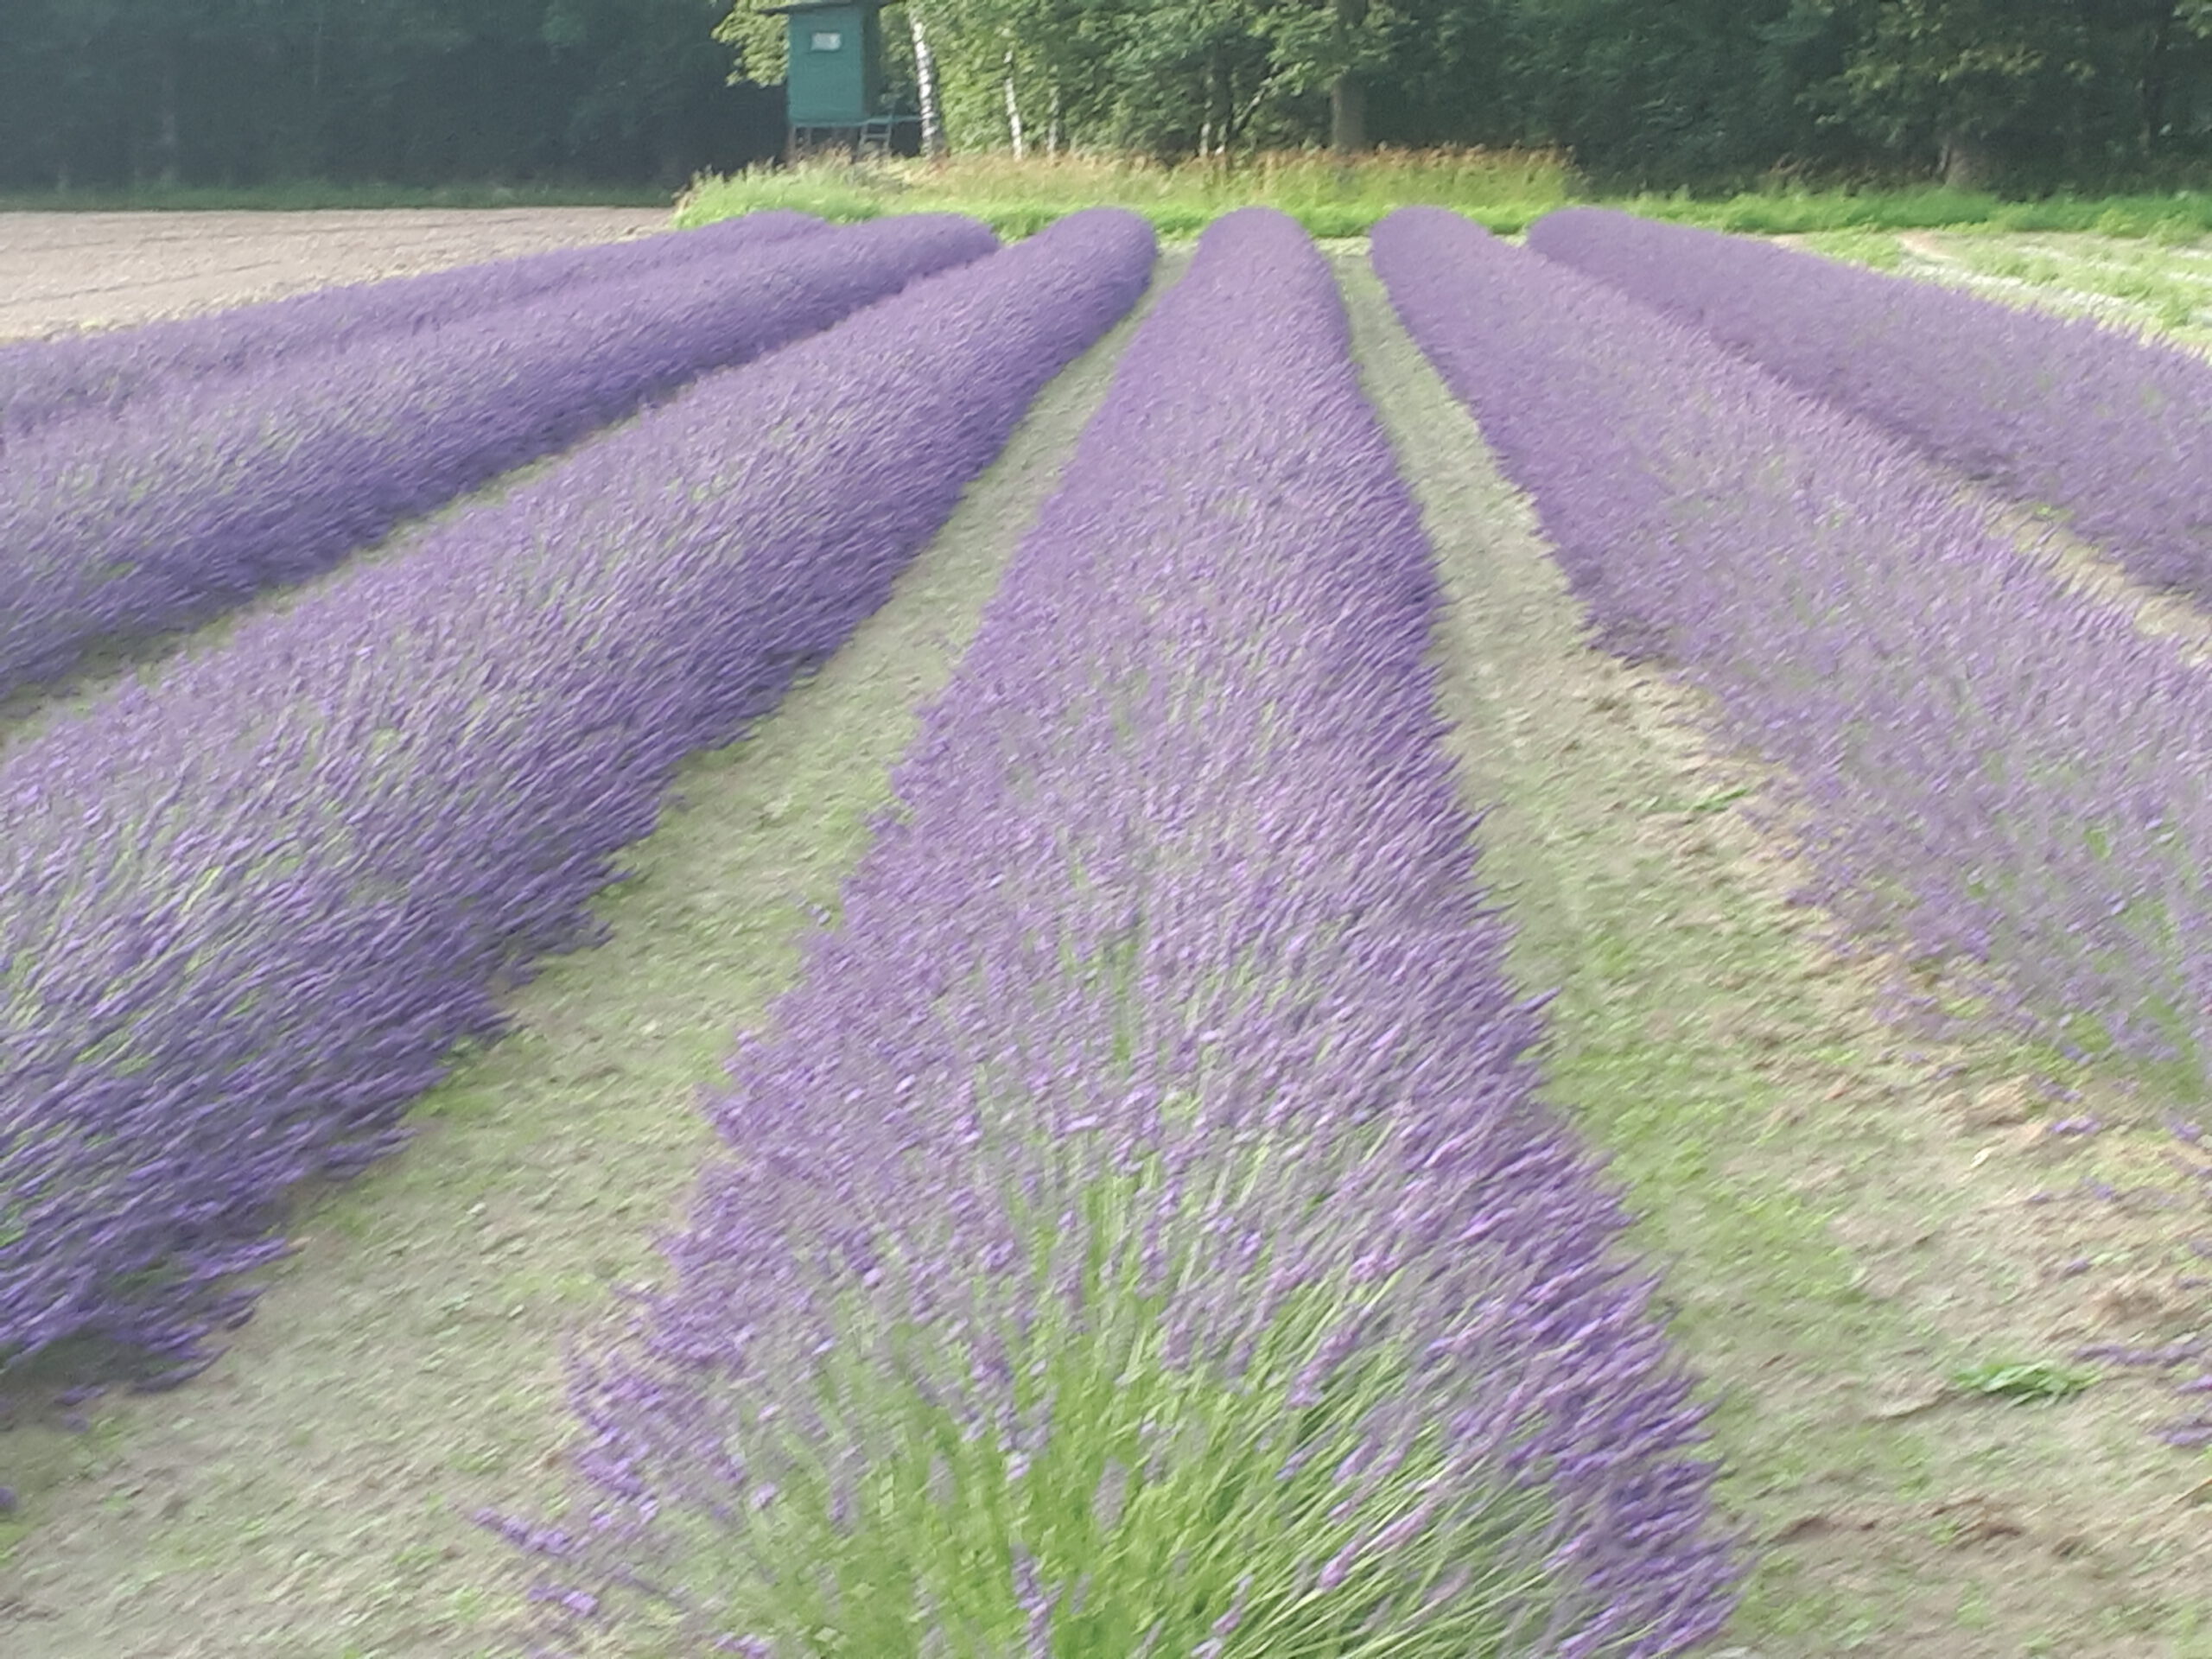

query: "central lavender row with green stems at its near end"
(485, 210), (1737, 1659)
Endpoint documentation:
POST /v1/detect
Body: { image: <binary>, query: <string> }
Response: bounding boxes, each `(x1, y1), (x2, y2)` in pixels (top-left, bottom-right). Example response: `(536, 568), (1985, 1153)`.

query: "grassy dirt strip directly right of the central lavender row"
(1338, 259), (2212, 1659)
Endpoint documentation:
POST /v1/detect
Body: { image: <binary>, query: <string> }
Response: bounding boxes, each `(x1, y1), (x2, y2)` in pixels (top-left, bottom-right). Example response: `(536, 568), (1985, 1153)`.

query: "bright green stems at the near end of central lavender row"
(614, 1164), (1551, 1656)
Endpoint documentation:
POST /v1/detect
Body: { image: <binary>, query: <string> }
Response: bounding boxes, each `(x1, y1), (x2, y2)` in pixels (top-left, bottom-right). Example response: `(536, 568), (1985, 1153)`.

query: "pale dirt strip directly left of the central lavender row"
(0, 257), (1184, 1659)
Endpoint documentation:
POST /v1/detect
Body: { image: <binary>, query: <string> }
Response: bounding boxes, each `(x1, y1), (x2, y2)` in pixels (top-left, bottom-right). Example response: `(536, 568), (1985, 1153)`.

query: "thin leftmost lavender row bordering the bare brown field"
(0, 213), (821, 451)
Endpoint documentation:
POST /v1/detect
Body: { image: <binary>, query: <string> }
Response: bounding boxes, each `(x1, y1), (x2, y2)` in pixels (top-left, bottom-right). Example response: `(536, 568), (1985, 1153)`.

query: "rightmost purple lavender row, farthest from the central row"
(1529, 208), (2212, 601)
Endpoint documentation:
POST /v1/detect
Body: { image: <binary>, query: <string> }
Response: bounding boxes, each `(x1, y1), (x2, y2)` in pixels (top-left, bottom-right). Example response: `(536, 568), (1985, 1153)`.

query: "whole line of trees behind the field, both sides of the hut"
(13, 0), (2212, 190)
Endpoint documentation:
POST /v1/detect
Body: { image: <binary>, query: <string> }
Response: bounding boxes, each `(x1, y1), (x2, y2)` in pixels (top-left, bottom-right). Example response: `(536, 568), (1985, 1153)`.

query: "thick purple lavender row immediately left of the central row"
(0, 213), (1153, 1385)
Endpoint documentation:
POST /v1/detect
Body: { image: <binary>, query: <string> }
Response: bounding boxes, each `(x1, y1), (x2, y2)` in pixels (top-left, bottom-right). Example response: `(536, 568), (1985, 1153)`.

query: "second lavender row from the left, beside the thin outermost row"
(0, 214), (998, 696)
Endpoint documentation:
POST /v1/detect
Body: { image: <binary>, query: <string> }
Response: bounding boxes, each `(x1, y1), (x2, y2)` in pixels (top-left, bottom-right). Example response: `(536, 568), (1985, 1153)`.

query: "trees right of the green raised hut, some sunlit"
(723, 0), (2212, 186)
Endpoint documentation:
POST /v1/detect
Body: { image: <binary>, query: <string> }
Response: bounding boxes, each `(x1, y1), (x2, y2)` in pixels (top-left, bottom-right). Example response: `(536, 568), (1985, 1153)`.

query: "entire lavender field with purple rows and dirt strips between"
(0, 210), (2212, 1659)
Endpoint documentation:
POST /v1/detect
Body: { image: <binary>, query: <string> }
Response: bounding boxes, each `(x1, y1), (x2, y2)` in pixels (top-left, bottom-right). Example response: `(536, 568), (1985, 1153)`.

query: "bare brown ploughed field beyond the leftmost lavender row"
(0, 208), (668, 340)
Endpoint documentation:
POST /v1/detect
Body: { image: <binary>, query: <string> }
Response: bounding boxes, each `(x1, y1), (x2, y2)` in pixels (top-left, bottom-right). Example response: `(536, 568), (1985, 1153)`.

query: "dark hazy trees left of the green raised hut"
(0, 0), (781, 190)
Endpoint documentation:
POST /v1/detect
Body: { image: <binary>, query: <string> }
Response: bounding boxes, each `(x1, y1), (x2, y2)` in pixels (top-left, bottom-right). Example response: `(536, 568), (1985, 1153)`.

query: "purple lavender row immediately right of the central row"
(1374, 210), (2212, 1082)
